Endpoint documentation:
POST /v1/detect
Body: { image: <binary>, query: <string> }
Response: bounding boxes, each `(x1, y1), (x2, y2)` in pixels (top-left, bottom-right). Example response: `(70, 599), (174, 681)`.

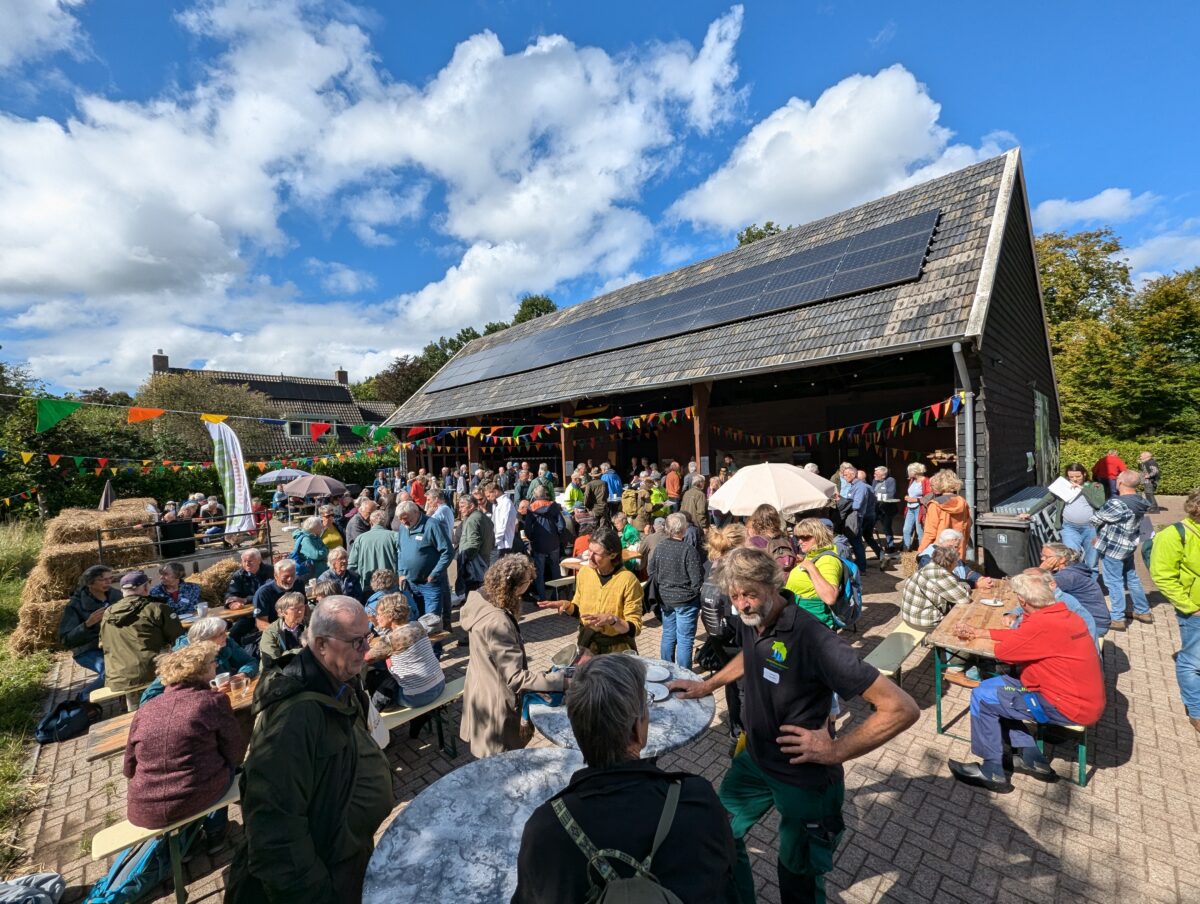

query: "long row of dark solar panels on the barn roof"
(427, 210), (941, 393)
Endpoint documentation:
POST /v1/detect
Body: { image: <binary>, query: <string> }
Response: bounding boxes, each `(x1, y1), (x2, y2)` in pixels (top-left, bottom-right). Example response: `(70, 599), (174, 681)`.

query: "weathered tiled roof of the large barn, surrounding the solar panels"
(385, 149), (1020, 426)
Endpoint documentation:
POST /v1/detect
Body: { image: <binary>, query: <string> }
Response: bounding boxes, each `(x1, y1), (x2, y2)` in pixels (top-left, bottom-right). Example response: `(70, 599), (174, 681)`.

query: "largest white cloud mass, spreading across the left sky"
(0, 0), (742, 388)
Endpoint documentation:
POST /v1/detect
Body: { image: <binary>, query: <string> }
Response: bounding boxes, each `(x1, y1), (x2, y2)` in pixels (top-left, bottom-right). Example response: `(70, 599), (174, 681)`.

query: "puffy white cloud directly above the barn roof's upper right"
(672, 65), (1010, 231)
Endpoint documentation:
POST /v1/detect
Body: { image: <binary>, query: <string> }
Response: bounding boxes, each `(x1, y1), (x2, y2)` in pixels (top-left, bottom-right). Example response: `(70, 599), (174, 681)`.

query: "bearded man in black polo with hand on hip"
(668, 549), (919, 904)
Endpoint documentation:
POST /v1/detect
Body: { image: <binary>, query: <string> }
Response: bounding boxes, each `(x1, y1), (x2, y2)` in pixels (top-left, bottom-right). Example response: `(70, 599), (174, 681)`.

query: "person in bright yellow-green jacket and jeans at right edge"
(1150, 489), (1200, 732)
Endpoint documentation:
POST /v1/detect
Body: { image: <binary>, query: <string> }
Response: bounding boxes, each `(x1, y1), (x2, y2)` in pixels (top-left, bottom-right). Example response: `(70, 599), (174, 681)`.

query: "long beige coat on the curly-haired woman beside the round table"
(458, 591), (565, 758)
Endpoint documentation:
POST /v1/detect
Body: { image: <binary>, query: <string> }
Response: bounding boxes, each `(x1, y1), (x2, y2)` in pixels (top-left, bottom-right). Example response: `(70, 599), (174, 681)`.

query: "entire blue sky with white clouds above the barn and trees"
(0, 0), (1200, 390)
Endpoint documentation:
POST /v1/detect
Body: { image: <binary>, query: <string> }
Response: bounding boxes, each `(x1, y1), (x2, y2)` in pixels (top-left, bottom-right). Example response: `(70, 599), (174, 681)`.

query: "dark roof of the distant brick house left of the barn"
(167, 367), (394, 459)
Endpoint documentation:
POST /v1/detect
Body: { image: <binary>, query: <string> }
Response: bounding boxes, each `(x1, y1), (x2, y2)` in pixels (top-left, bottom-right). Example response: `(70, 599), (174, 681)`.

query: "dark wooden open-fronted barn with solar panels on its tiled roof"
(386, 149), (1058, 511)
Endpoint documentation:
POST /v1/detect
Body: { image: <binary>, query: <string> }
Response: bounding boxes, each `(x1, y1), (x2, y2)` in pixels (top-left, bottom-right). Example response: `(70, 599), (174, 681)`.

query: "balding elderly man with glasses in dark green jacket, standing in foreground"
(226, 595), (394, 904)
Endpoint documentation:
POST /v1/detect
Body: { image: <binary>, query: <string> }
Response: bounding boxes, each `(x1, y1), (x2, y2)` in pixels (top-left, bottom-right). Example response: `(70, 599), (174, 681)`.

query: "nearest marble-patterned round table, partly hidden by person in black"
(362, 748), (583, 904)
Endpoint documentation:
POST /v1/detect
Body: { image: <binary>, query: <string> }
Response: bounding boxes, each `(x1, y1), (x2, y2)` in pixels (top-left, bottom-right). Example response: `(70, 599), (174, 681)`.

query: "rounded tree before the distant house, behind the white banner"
(136, 371), (278, 460)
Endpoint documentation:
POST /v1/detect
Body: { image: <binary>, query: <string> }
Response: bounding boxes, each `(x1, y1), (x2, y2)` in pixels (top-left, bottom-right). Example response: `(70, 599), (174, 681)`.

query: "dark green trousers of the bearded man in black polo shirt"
(720, 750), (846, 904)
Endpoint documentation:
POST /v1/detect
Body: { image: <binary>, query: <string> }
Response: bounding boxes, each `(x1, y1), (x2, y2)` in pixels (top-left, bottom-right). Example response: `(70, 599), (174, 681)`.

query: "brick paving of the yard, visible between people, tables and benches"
(16, 499), (1200, 904)
